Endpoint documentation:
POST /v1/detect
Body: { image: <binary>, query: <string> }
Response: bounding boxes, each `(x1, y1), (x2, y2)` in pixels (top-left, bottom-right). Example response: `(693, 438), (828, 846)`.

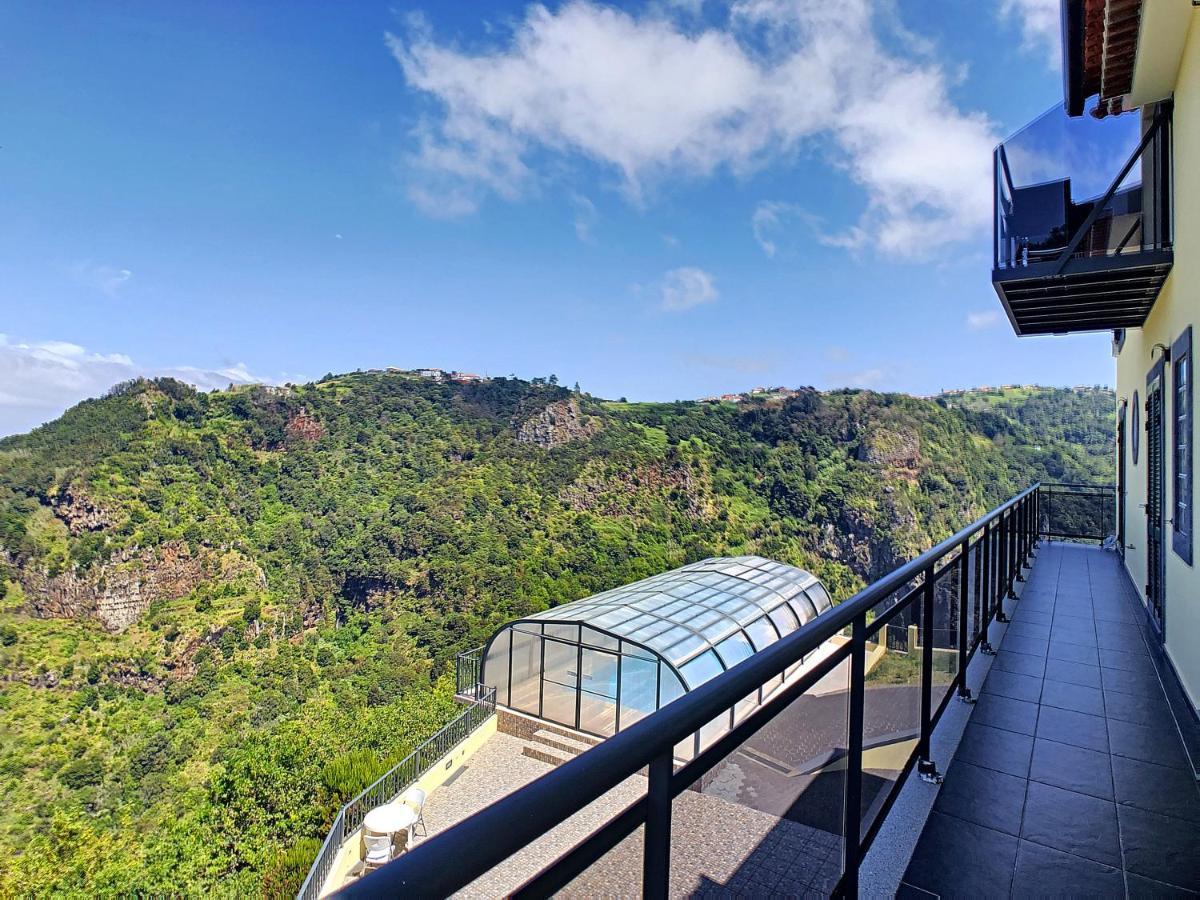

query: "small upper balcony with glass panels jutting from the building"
(991, 103), (1172, 335)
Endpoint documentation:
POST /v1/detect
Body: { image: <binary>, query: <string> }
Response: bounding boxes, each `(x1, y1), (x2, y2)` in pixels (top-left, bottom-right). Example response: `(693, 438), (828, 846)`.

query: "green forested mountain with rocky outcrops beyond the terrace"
(0, 372), (1114, 896)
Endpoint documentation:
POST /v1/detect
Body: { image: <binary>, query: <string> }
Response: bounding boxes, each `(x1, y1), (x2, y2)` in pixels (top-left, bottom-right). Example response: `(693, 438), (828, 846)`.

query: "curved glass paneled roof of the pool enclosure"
(510, 556), (832, 689)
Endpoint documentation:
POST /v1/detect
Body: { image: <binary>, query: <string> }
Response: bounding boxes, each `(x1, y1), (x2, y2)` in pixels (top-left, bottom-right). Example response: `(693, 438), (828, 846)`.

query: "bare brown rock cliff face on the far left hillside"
(17, 541), (262, 631)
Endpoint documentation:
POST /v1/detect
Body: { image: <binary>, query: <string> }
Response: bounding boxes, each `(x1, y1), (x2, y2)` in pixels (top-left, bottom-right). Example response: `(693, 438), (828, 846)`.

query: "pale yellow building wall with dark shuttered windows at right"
(1117, 8), (1200, 707)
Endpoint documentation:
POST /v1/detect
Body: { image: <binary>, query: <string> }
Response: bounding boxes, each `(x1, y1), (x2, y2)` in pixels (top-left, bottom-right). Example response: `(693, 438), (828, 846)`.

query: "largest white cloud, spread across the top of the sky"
(388, 0), (996, 257)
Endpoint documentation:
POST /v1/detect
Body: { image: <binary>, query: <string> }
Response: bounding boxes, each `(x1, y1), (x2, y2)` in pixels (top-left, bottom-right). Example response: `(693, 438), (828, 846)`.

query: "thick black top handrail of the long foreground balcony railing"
(338, 484), (1039, 898)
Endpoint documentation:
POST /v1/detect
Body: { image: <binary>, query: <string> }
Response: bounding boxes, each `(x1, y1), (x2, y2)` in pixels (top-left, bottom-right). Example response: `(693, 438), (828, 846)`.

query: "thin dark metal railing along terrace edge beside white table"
(296, 685), (496, 900)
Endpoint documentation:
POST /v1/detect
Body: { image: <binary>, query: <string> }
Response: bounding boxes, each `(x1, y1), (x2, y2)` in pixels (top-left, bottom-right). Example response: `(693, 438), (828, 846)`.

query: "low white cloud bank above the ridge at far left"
(0, 335), (274, 434)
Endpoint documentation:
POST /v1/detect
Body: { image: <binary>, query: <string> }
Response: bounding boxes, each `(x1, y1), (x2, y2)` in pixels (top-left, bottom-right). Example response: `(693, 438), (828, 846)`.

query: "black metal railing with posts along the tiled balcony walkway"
(341, 485), (1042, 898)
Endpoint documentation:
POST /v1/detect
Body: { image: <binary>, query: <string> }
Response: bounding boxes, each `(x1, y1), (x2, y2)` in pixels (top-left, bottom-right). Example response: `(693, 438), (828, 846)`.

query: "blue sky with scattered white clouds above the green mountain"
(0, 0), (1112, 434)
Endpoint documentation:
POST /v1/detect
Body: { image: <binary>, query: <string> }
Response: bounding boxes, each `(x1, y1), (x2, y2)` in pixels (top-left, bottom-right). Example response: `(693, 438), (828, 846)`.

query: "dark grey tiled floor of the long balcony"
(900, 544), (1200, 896)
